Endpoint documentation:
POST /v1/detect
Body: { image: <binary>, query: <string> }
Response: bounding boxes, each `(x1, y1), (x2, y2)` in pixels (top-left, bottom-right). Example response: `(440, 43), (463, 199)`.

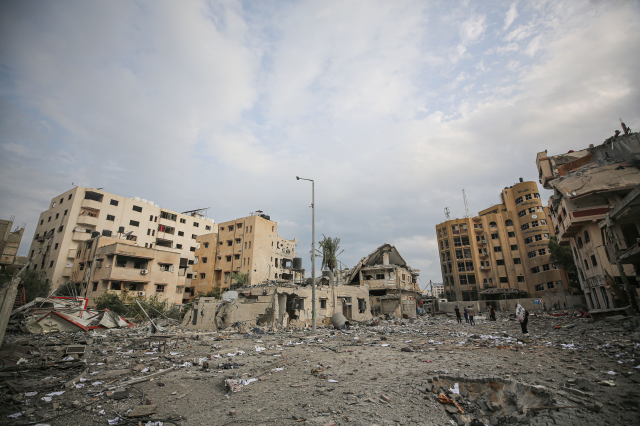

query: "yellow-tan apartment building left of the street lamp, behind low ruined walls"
(194, 212), (304, 292)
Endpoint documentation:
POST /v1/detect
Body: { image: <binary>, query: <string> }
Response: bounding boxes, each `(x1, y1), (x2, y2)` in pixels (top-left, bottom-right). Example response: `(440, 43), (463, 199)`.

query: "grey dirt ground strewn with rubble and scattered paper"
(0, 315), (640, 426)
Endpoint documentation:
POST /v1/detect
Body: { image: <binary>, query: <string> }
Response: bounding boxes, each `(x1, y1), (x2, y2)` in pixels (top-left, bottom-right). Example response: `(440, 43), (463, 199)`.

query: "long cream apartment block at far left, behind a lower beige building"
(29, 187), (217, 302)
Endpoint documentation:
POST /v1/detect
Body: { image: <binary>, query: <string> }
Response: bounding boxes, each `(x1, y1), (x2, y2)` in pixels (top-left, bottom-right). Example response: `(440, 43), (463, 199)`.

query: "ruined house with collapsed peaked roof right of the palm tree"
(345, 244), (420, 318)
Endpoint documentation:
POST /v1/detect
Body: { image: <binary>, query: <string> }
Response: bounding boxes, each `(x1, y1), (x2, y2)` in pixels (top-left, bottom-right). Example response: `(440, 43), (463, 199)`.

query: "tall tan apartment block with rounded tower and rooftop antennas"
(436, 179), (569, 301)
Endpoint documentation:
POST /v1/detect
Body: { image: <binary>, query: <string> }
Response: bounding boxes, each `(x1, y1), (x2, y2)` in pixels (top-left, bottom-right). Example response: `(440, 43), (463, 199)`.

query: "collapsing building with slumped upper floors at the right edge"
(536, 124), (640, 309)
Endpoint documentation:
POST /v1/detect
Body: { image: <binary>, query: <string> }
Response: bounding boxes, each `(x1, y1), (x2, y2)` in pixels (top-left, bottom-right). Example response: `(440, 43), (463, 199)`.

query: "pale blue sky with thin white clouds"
(0, 0), (640, 288)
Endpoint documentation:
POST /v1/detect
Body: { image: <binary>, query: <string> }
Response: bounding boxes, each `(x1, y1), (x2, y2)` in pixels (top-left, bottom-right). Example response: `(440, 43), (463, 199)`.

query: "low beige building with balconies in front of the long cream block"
(70, 236), (185, 306)
